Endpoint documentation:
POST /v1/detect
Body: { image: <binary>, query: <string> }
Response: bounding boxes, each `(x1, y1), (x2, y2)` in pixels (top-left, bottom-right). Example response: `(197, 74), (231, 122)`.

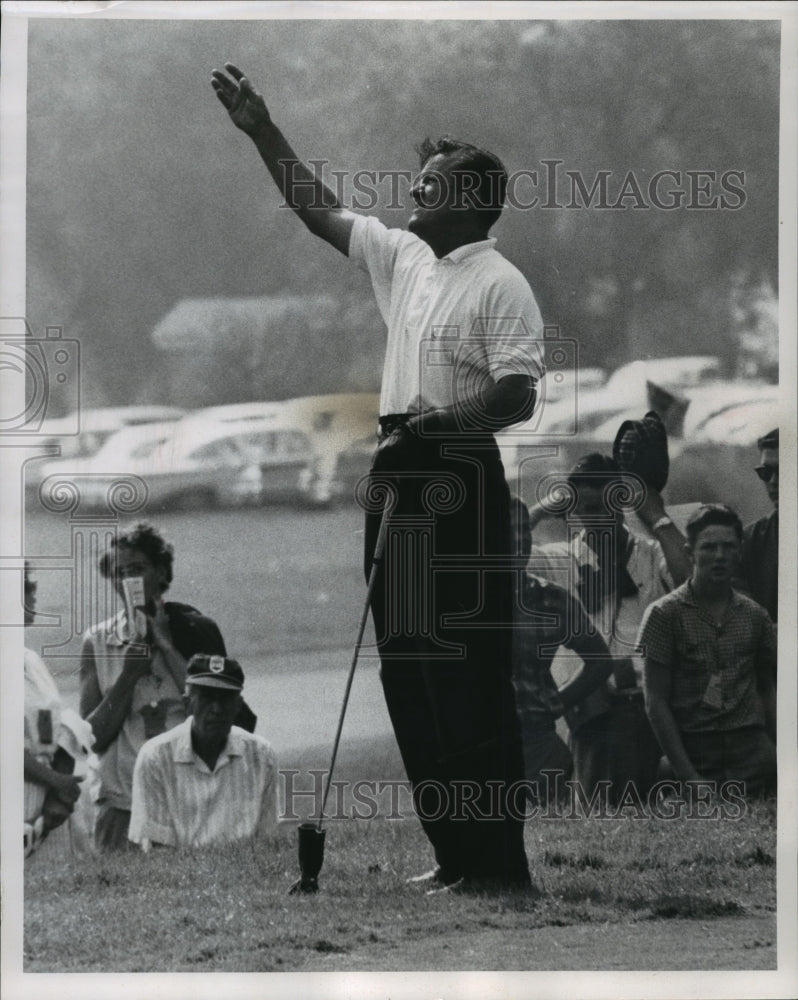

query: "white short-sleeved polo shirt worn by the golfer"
(349, 215), (545, 415)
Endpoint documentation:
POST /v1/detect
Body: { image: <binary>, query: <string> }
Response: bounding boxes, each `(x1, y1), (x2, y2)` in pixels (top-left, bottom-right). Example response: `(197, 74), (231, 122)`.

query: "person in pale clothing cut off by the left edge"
(24, 562), (92, 856)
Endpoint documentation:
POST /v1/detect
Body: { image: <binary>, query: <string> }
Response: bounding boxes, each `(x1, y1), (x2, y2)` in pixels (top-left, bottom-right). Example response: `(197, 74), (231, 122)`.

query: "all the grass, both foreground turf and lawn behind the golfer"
(24, 509), (776, 972)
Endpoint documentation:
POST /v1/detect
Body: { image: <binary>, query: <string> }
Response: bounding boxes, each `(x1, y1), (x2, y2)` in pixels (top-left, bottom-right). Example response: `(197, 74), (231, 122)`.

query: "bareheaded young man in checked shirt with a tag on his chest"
(640, 504), (776, 793)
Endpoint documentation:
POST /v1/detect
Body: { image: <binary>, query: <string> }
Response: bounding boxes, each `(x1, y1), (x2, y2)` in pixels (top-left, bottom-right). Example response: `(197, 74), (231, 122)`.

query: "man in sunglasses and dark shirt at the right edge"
(740, 428), (779, 622)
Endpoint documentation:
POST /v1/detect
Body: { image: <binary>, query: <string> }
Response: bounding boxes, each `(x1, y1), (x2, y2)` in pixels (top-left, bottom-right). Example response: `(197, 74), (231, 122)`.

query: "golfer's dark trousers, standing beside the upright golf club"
(366, 436), (529, 884)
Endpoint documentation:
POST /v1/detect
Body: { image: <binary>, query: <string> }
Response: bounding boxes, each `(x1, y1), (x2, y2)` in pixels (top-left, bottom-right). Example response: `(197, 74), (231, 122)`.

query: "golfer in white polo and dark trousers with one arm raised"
(212, 64), (543, 890)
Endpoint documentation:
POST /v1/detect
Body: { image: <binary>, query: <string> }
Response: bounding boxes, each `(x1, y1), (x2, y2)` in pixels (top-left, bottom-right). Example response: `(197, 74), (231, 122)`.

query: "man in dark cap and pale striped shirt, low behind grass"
(130, 654), (277, 851)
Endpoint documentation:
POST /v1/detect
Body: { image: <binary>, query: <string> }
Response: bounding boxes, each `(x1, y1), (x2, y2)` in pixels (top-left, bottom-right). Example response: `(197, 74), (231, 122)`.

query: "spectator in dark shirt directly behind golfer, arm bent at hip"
(511, 499), (612, 805)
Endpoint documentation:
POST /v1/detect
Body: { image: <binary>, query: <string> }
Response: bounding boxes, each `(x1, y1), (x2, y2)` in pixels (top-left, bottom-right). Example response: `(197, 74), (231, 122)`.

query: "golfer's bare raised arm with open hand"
(216, 63), (356, 256)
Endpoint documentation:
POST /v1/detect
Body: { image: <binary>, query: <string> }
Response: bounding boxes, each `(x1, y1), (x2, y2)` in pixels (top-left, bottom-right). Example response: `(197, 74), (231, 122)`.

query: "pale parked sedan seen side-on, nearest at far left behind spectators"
(40, 419), (313, 510)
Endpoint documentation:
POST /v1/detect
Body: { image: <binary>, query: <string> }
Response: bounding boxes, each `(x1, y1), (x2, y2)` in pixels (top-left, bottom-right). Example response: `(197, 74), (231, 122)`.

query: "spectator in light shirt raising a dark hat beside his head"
(530, 453), (689, 802)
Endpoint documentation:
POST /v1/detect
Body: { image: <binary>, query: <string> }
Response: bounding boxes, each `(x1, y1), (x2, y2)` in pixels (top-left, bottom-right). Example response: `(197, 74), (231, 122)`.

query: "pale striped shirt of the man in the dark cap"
(128, 716), (277, 847)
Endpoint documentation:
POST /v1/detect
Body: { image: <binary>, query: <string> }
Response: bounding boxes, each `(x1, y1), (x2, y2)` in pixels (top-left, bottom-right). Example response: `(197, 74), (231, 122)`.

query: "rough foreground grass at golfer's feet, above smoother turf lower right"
(24, 803), (776, 972)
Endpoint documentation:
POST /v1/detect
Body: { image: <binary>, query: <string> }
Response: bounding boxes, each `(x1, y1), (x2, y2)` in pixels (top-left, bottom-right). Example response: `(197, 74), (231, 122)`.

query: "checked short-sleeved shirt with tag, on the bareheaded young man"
(638, 581), (776, 733)
